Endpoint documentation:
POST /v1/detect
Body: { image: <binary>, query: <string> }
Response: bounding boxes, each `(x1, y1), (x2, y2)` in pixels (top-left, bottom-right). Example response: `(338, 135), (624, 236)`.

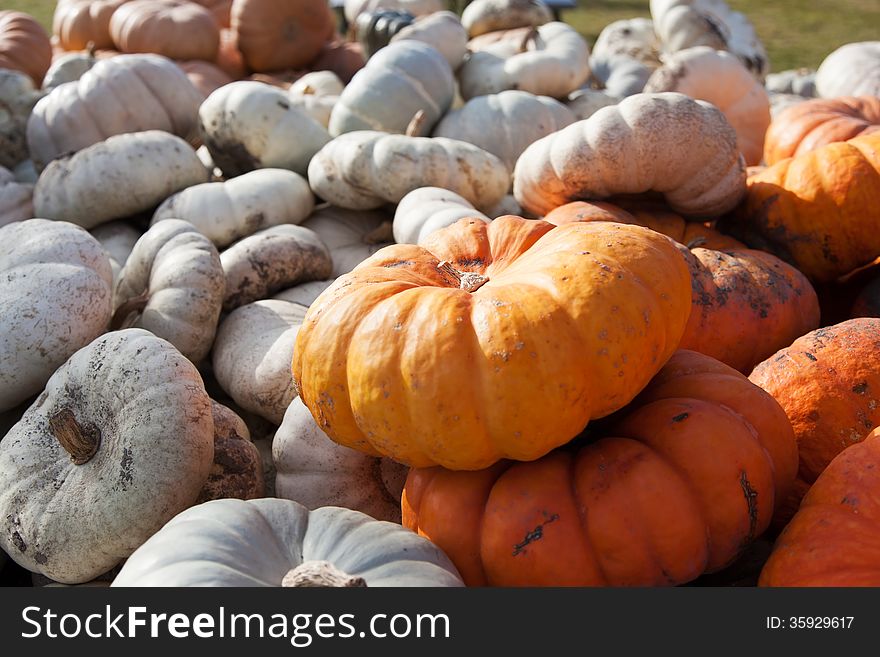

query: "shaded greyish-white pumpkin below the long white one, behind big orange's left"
(302, 205), (393, 276)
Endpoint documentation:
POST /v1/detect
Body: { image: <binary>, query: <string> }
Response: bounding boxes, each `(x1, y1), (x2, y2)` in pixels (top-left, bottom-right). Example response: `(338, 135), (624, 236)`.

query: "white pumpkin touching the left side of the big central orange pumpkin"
(212, 299), (307, 425)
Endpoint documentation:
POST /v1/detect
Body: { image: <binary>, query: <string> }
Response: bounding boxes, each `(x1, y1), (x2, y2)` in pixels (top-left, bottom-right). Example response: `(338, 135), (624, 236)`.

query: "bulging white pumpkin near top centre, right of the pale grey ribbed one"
(458, 21), (590, 100)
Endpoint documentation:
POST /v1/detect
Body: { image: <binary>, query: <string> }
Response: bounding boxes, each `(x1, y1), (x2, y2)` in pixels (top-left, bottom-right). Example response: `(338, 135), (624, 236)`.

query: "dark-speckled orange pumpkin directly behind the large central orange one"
(545, 201), (819, 374)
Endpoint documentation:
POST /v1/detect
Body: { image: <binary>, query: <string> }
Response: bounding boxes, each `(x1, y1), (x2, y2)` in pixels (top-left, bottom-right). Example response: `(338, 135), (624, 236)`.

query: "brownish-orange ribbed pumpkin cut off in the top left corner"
(0, 11), (52, 87)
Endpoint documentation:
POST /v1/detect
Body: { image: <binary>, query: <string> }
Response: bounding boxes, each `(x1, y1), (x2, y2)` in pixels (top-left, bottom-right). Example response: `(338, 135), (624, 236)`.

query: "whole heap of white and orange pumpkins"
(0, 0), (880, 586)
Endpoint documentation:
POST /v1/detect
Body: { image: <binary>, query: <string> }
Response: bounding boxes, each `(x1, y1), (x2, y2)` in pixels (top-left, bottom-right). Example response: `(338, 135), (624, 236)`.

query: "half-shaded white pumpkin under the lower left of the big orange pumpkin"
(272, 398), (407, 523)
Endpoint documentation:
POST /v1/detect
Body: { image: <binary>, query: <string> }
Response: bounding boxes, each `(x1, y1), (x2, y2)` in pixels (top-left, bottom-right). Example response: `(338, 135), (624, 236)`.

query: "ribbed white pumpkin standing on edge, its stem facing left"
(113, 219), (226, 363)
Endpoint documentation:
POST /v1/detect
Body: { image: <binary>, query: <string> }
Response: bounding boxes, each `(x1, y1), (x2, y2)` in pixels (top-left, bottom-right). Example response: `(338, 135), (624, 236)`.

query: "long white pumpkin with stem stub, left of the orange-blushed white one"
(309, 132), (510, 210)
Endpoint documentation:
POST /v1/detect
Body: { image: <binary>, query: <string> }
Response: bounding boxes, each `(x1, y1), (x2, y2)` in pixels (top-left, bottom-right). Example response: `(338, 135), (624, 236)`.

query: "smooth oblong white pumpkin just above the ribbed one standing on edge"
(152, 169), (315, 247)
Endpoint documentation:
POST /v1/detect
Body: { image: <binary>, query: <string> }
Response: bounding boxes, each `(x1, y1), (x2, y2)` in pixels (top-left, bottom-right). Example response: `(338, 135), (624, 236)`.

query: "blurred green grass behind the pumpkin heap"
(3, 0), (880, 71)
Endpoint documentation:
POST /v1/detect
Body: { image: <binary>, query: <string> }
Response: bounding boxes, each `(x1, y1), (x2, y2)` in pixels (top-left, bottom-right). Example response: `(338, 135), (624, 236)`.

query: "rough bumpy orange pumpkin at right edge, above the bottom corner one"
(749, 318), (880, 526)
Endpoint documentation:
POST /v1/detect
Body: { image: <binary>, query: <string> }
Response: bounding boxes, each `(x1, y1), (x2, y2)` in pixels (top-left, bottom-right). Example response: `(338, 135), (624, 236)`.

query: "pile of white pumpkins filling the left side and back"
(0, 0), (880, 586)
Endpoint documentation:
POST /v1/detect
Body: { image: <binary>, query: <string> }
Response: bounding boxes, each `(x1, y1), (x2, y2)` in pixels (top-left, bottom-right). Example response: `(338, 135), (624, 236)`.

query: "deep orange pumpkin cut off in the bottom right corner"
(758, 427), (880, 586)
